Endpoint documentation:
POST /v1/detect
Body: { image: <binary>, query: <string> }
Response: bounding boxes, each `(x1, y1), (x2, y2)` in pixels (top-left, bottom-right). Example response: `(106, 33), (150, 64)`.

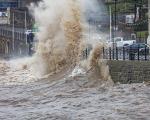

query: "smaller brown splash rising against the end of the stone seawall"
(78, 43), (113, 87)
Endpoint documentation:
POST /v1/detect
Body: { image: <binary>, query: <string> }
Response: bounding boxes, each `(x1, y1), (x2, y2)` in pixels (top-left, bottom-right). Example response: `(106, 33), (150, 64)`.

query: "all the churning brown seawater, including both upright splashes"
(0, 0), (150, 120)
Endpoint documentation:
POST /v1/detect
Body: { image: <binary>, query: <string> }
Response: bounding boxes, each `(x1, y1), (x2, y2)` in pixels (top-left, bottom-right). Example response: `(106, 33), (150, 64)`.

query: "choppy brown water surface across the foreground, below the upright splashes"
(0, 61), (150, 120)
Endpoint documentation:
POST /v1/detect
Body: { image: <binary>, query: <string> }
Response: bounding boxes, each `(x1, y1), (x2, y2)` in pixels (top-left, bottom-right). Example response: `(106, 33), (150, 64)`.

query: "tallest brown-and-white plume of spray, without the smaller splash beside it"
(30, 0), (82, 75)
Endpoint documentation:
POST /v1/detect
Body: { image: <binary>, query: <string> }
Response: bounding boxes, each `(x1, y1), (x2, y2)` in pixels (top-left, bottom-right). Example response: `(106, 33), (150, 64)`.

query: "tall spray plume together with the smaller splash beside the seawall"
(30, 0), (110, 84)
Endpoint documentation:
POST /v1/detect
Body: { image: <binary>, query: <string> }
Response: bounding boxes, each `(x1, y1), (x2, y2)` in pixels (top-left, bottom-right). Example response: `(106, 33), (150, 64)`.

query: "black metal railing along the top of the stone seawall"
(102, 46), (150, 61)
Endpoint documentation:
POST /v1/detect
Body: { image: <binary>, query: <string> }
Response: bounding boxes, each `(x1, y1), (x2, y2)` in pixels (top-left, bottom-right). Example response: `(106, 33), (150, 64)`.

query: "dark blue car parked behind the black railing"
(126, 43), (149, 55)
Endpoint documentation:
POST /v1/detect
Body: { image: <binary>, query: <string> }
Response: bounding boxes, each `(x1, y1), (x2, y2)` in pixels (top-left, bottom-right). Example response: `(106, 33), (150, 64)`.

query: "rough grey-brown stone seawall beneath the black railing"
(108, 60), (150, 84)
